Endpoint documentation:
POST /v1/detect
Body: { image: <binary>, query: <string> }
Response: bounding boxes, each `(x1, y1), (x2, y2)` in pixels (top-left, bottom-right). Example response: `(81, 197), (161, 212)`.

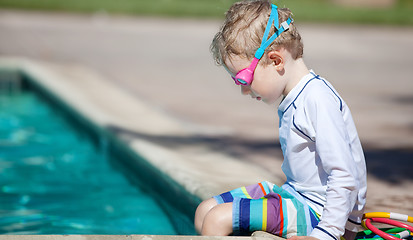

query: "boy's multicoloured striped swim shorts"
(214, 182), (320, 238)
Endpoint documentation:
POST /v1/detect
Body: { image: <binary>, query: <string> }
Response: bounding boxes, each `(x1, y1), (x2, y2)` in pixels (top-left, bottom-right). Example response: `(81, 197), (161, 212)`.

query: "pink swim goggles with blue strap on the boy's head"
(227, 4), (293, 85)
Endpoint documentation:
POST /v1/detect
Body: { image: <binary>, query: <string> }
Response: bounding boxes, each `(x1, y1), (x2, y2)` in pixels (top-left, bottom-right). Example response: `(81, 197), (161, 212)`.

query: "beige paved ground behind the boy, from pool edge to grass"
(0, 10), (413, 237)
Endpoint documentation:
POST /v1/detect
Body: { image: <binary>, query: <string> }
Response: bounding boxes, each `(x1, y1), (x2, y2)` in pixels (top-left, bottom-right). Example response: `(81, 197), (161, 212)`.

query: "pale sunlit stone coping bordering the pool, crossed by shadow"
(0, 57), (281, 240)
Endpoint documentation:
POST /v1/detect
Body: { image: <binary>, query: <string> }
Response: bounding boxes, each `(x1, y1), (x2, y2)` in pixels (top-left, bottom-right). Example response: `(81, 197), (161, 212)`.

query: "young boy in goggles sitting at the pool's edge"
(195, 0), (367, 239)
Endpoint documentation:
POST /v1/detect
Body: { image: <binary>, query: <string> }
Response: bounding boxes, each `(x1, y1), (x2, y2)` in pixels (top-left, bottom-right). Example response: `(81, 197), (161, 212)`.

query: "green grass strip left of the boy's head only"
(0, 0), (238, 17)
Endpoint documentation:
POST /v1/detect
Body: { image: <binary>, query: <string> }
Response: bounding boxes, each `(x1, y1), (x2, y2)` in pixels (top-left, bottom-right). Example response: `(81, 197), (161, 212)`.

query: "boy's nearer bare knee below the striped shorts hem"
(201, 203), (232, 236)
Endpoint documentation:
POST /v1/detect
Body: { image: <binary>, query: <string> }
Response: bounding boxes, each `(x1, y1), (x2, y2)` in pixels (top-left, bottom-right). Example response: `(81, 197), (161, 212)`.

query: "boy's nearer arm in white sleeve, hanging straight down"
(306, 92), (358, 239)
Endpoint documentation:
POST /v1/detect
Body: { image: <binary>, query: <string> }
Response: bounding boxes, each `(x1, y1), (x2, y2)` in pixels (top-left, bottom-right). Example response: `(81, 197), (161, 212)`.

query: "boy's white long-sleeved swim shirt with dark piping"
(278, 71), (367, 239)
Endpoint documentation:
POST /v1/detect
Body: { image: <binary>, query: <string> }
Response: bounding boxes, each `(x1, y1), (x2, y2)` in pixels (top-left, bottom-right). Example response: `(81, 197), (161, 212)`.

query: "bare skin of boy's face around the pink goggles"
(224, 56), (286, 104)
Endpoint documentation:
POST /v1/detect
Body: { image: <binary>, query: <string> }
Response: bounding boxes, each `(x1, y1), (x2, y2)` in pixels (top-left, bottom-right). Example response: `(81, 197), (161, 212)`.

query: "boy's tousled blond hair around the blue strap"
(211, 0), (303, 65)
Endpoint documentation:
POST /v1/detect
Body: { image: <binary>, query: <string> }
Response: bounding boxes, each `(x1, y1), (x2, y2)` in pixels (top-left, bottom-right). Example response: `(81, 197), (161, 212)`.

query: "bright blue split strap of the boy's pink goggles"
(255, 4), (293, 59)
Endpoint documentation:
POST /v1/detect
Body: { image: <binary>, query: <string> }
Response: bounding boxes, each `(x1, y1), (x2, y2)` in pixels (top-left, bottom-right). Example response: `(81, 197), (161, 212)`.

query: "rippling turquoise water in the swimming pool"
(0, 91), (177, 234)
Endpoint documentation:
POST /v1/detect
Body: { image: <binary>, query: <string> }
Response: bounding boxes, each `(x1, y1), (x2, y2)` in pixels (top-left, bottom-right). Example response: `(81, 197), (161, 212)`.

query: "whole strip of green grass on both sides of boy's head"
(0, 0), (413, 25)
